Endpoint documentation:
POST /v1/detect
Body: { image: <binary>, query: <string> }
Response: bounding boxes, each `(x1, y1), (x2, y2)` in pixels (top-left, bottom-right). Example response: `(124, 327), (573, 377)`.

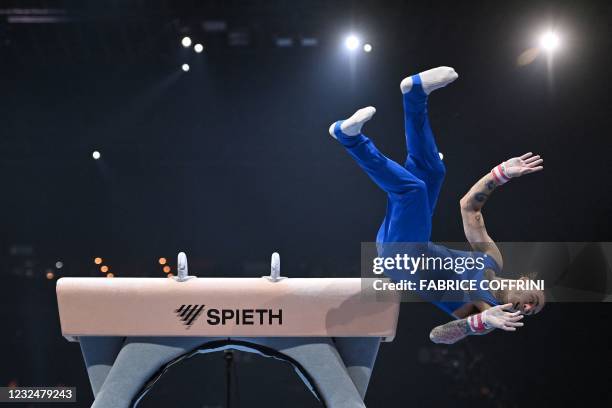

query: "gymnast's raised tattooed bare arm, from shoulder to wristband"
(459, 173), (503, 268)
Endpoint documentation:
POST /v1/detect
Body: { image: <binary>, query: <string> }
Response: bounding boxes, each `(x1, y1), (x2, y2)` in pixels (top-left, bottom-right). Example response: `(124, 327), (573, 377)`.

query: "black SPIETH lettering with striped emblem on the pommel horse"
(174, 305), (283, 329)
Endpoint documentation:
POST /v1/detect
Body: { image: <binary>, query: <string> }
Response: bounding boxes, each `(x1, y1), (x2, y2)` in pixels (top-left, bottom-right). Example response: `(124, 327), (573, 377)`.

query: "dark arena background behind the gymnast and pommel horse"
(0, 0), (612, 408)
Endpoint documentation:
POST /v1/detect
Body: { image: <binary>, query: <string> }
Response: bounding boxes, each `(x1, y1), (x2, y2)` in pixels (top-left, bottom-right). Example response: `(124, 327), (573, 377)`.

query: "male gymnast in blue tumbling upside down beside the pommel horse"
(329, 67), (545, 344)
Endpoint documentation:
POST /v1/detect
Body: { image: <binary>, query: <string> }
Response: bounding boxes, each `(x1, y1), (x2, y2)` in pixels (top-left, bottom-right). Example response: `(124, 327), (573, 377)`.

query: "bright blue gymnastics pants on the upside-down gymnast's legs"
(334, 75), (446, 243)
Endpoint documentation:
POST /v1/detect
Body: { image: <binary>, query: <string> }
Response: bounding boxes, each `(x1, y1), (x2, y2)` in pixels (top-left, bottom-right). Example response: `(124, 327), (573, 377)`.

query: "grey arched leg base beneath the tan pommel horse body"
(80, 337), (380, 408)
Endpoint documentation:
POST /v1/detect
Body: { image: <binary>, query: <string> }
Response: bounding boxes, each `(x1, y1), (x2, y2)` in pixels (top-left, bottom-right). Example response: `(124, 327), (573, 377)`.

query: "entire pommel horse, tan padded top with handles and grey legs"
(57, 252), (399, 408)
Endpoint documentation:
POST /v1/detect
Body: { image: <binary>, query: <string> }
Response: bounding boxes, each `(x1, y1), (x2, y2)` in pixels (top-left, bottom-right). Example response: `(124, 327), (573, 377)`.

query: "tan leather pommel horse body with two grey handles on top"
(57, 254), (399, 341)
